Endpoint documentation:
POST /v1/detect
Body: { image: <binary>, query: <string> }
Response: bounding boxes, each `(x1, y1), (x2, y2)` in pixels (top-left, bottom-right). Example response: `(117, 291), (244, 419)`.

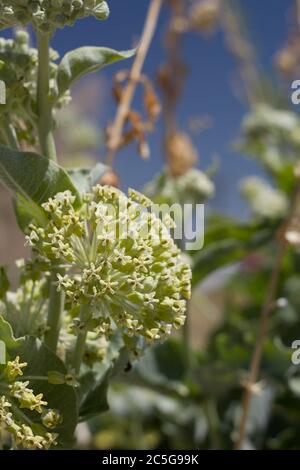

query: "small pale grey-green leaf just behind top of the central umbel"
(68, 163), (109, 194)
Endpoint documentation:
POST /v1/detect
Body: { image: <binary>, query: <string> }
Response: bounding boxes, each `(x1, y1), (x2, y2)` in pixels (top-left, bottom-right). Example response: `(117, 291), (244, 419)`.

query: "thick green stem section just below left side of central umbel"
(45, 269), (65, 352)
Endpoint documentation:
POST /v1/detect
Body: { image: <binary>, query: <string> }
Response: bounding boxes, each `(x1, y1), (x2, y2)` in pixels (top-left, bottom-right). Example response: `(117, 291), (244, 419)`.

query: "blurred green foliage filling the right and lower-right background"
(84, 103), (300, 449)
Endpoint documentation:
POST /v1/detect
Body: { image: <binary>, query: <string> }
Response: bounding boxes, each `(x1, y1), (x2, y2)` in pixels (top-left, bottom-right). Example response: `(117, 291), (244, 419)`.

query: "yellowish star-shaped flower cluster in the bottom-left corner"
(0, 356), (61, 449)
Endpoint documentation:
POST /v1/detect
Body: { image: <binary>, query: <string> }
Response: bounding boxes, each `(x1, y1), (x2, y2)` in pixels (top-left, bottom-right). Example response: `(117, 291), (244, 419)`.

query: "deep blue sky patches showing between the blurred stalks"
(1, 0), (299, 215)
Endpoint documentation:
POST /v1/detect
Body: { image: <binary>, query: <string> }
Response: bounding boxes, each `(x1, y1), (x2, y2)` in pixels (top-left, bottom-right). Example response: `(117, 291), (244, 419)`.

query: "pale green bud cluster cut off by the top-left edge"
(0, 0), (109, 32)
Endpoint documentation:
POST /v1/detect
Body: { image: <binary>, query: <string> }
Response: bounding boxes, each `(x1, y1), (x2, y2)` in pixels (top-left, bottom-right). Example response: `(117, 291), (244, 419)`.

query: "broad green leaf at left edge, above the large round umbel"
(0, 145), (80, 230)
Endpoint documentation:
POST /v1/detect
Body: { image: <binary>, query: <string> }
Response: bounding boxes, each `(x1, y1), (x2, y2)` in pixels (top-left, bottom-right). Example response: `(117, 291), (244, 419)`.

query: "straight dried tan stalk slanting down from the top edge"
(106, 0), (163, 166)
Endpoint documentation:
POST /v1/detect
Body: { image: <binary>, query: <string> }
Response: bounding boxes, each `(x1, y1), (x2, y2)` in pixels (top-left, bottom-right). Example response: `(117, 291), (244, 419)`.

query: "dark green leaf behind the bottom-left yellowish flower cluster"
(18, 337), (77, 449)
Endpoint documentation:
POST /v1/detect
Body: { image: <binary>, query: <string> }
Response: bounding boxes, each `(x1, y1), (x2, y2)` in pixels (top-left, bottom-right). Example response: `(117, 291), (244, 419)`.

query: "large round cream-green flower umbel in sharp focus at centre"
(27, 185), (191, 343)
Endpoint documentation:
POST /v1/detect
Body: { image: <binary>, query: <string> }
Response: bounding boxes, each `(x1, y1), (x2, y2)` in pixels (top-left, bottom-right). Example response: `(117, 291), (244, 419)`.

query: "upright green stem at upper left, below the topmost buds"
(37, 32), (57, 161)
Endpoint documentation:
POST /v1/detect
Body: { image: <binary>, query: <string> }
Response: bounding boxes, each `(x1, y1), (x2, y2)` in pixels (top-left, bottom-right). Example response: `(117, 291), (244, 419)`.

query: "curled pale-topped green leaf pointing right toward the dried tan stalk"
(57, 47), (135, 95)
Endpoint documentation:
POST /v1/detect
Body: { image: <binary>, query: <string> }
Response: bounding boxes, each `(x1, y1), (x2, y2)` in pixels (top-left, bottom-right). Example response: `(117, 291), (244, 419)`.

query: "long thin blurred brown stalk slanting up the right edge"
(234, 184), (300, 450)
